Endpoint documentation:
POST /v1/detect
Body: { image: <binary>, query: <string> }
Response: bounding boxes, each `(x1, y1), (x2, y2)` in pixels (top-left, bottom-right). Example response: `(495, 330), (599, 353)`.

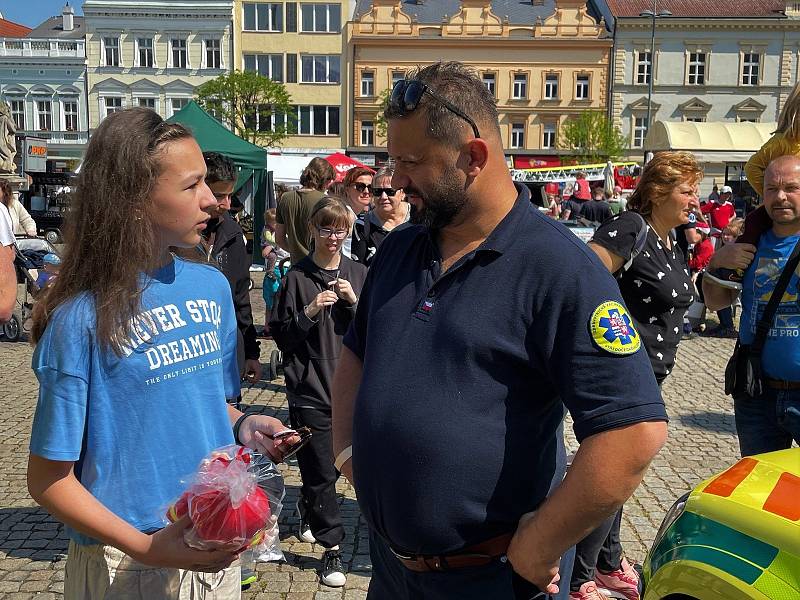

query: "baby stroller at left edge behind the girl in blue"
(0, 236), (59, 342)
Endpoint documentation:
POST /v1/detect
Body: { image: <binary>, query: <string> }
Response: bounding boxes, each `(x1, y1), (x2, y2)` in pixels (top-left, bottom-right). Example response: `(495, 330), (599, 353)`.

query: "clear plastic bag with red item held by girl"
(167, 445), (283, 551)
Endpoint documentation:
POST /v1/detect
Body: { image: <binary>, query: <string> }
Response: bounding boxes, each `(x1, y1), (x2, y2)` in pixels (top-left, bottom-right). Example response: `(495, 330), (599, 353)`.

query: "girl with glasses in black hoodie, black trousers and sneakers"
(269, 196), (371, 587)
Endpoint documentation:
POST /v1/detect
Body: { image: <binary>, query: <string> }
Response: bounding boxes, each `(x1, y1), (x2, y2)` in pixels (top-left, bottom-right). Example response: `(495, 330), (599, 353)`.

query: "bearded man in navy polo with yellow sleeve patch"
(333, 63), (666, 600)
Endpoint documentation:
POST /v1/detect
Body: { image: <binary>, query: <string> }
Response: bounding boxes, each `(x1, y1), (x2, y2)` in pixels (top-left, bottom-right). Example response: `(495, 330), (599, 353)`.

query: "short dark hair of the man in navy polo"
(383, 61), (500, 147)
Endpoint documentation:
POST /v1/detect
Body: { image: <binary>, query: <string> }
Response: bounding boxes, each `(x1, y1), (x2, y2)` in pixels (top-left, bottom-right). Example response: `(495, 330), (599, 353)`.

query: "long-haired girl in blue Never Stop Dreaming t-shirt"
(28, 108), (296, 600)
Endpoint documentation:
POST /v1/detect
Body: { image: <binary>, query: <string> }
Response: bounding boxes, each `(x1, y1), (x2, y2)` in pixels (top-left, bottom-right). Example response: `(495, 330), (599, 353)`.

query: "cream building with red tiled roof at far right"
(606, 0), (800, 192)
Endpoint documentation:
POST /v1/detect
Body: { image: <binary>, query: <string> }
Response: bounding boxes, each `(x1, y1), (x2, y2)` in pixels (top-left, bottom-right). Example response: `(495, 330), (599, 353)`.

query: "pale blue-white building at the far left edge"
(0, 5), (89, 161)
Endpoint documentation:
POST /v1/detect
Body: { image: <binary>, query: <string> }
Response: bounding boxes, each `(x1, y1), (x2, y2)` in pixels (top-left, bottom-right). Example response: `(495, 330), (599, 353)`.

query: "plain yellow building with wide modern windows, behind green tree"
(233, 0), (354, 156)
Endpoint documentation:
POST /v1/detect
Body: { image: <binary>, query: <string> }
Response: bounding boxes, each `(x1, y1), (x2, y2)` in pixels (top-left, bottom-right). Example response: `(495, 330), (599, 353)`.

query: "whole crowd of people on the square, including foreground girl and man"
(0, 63), (800, 600)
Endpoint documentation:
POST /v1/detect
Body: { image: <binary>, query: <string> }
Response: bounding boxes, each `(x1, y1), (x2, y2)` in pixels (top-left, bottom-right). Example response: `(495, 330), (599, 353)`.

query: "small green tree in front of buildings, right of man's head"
(559, 110), (628, 163)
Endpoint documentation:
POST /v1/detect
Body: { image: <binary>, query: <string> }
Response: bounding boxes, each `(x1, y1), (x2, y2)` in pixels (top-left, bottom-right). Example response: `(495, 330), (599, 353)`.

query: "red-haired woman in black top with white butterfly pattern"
(570, 152), (703, 600)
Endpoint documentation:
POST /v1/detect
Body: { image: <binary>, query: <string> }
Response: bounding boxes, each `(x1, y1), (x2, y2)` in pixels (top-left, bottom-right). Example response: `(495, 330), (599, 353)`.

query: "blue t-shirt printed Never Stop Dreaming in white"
(30, 259), (240, 544)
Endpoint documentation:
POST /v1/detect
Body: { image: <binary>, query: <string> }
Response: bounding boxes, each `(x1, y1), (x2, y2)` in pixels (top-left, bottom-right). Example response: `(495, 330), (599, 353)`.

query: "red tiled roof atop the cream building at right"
(607, 0), (786, 18)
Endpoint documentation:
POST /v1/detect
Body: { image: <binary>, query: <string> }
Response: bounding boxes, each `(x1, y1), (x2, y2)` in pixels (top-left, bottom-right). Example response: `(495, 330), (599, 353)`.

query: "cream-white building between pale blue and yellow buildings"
(83, 0), (233, 129)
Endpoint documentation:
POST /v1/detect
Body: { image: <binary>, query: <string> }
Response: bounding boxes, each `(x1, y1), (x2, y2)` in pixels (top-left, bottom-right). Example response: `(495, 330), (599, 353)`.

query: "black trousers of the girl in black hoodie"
(289, 402), (344, 548)
